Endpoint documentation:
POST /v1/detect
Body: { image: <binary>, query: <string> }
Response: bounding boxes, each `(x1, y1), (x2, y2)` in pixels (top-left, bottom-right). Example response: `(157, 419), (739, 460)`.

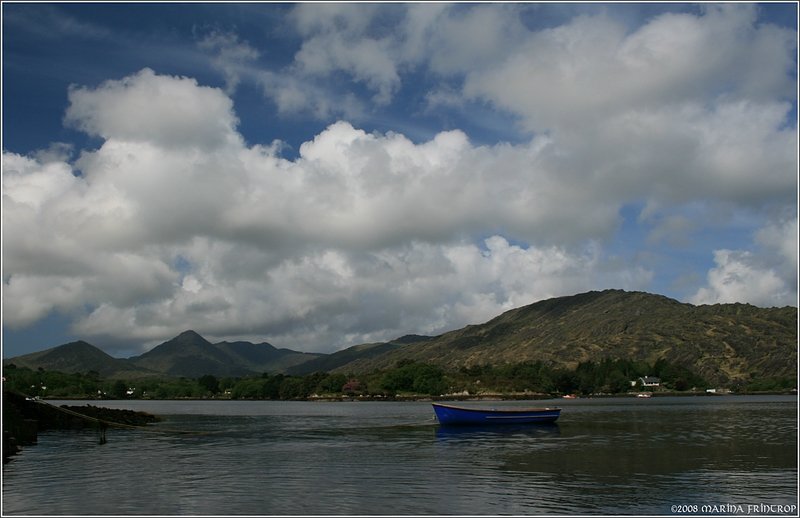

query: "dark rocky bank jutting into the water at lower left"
(3, 390), (159, 463)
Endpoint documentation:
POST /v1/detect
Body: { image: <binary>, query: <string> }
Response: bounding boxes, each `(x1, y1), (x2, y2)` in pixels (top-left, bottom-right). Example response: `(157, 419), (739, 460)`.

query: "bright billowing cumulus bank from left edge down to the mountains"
(3, 70), (647, 349)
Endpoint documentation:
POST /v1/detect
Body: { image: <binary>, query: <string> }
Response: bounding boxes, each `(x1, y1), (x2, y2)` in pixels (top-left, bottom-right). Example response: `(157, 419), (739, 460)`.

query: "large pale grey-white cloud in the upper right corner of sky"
(464, 5), (796, 131)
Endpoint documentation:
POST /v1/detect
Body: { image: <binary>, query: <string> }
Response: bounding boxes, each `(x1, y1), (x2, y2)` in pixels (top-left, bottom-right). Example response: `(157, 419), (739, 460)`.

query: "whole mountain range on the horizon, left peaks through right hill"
(3, 290), (798, 383)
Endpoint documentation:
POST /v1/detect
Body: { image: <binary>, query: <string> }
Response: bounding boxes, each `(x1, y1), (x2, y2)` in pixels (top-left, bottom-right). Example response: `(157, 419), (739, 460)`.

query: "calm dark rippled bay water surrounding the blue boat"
(2, 396), (798, 515)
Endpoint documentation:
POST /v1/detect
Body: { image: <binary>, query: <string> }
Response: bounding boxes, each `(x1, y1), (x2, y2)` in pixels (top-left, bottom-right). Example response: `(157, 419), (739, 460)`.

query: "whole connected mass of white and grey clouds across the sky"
(3, 4), (797, 356)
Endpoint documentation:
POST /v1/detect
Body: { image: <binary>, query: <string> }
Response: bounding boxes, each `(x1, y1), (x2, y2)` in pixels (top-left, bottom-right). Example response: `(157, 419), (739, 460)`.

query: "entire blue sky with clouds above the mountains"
(2, 2), (798, 357)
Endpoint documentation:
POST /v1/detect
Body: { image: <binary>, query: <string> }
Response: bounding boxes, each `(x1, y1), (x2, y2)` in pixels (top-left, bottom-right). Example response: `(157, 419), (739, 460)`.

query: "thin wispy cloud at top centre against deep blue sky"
(197, 4), (526, 120)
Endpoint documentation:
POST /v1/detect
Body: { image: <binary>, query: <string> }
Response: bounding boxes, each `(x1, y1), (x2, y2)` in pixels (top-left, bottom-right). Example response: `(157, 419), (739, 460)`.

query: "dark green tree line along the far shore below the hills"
(4, 359), (796, 400)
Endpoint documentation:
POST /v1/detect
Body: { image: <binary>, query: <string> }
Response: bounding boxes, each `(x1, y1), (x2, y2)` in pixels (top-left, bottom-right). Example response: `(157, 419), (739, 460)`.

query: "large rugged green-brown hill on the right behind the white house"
(324, 290), (797, 383)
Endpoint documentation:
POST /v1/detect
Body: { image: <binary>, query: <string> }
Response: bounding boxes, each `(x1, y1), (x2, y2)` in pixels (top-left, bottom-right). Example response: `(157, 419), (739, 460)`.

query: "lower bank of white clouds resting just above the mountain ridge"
(65, 236), (649, 350)
